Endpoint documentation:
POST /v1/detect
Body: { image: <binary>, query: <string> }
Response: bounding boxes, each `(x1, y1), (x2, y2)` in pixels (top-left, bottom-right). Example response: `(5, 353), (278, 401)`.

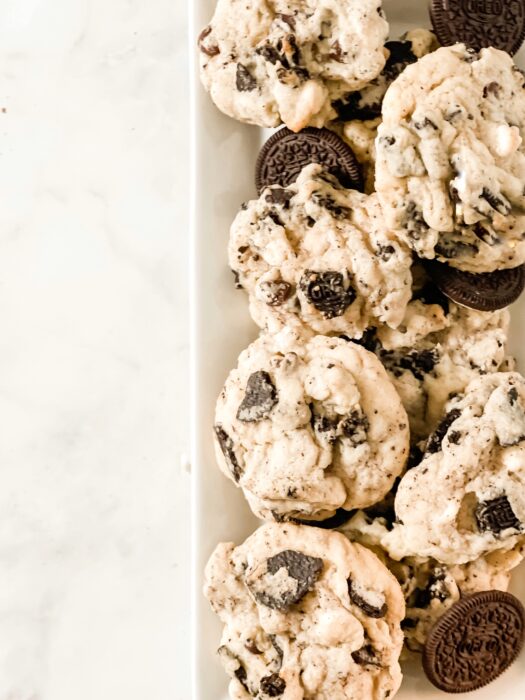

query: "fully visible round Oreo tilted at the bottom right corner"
(423, 591), (525, 693)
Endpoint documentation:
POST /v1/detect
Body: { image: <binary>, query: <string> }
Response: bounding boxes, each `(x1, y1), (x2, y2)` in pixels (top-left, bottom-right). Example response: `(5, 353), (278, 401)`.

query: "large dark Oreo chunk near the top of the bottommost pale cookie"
(252, 549), (323, 611)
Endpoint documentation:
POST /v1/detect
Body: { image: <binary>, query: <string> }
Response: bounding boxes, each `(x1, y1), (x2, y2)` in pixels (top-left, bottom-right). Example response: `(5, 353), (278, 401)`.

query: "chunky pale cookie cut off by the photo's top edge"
(199, 0), (388, 131)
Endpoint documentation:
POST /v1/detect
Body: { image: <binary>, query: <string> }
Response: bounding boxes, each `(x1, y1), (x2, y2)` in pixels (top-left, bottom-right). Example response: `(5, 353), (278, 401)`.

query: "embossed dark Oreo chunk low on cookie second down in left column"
(299, 270), (356, 319)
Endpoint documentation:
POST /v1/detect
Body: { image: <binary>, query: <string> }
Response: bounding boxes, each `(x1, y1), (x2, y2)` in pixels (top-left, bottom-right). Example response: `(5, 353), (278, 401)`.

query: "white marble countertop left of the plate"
(0, 0), (190, 700)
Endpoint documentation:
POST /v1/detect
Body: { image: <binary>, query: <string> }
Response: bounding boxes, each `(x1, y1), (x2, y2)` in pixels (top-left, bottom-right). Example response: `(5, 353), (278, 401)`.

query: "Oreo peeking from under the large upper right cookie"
(425, 260), (525, 311)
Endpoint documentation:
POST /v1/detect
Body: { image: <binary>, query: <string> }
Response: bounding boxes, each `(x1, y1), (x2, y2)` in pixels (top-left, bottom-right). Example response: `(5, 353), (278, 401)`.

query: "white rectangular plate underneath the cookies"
(190, 0), (525, 700)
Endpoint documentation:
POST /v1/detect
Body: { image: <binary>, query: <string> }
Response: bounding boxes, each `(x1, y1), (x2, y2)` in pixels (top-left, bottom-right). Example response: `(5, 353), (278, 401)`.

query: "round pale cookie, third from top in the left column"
(215, 331), (408, 520)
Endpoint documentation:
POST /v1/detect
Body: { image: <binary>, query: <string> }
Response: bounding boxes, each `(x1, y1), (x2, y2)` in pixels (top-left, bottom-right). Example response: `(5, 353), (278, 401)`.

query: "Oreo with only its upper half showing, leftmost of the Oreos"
(255, 127), (363, 194)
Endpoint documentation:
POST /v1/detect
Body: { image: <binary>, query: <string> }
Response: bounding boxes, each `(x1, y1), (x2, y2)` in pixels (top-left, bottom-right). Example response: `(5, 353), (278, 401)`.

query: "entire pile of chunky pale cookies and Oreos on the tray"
(199, 0), (525, 700)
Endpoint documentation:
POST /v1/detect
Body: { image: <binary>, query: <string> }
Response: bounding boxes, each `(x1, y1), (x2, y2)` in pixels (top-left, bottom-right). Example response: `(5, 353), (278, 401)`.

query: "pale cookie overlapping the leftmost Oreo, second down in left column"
(229, 164), (412, 337)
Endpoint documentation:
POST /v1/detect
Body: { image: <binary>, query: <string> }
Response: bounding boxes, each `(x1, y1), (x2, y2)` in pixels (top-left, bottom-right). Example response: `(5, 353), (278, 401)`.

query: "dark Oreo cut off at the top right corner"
(430, 0), (525, 55)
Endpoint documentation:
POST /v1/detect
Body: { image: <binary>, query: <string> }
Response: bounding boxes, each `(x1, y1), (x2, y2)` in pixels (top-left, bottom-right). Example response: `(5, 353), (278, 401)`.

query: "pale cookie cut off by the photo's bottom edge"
(205, 523), (405, 700)
